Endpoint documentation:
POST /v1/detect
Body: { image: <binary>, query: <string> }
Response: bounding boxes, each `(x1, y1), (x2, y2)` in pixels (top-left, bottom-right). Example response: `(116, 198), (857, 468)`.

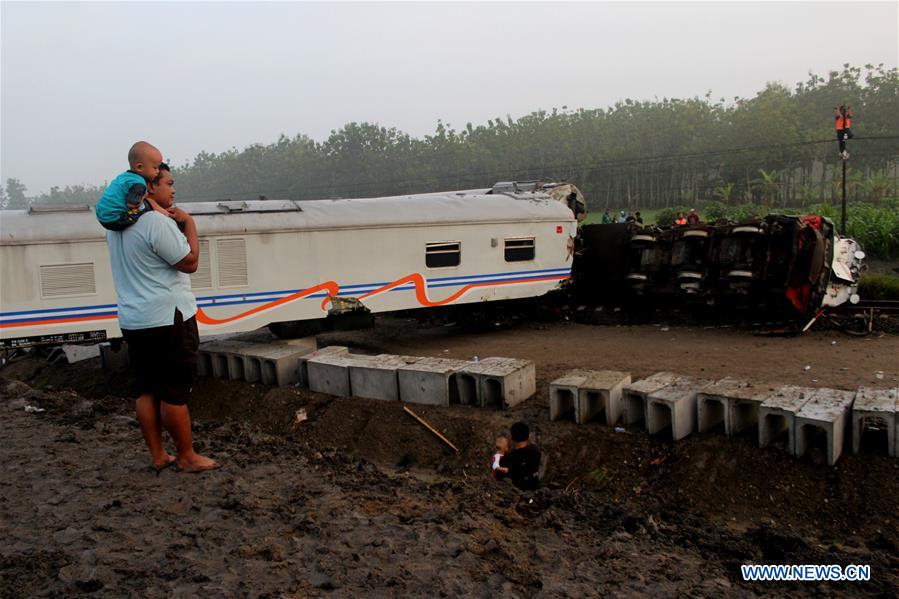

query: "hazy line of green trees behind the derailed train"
(0, 64), (899, 209)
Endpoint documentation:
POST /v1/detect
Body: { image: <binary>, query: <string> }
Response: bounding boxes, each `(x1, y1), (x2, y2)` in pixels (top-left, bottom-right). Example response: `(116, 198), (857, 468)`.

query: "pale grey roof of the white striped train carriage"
(0, 190), (574, 245)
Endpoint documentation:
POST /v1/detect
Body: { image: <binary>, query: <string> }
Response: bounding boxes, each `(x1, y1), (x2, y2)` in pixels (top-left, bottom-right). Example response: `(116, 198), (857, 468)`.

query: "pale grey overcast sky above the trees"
(0, 1), (899, 195)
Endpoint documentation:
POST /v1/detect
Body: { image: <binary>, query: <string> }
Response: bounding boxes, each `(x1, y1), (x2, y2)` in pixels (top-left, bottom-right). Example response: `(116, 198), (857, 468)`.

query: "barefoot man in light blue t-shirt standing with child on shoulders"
(106, 163), (219, 472)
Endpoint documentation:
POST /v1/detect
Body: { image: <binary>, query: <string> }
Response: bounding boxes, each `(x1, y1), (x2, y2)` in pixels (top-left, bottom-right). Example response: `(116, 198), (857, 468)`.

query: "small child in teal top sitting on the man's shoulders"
(94, 141), (162, 231)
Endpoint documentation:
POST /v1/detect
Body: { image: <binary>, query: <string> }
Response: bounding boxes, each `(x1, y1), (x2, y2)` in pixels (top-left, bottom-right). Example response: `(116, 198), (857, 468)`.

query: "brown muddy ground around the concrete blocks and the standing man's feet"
(0, 319), (899, 597)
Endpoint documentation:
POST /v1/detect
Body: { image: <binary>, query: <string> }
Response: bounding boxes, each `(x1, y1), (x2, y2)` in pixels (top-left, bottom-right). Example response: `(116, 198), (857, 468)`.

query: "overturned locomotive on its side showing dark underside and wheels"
(574, 214), (864, 319)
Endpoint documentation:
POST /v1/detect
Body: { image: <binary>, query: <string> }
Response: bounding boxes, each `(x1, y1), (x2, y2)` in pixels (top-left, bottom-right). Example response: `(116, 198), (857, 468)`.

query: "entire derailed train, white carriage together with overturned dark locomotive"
(0, 181), (863, 348)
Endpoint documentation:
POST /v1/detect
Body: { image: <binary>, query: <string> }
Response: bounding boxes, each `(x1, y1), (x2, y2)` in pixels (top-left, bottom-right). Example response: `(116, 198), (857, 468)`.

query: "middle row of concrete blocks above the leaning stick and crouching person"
(297, 346), (536, 408)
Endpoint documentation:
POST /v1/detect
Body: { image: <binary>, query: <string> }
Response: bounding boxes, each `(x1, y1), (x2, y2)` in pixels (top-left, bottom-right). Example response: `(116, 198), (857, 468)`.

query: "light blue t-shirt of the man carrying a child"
(106, 210), (197, 329)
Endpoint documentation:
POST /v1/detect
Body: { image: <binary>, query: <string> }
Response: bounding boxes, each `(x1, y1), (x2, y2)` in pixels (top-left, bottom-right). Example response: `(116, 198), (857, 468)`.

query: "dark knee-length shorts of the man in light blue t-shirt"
(122, 310), (200, 406)
